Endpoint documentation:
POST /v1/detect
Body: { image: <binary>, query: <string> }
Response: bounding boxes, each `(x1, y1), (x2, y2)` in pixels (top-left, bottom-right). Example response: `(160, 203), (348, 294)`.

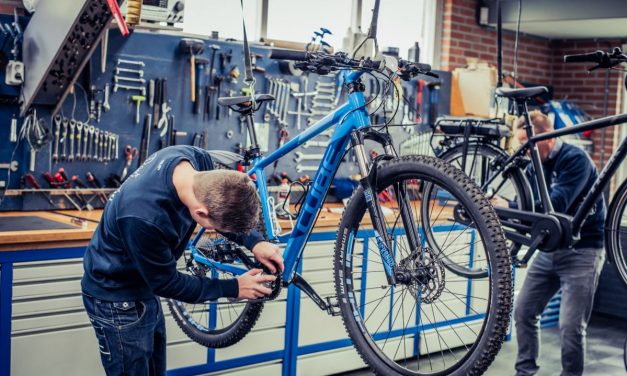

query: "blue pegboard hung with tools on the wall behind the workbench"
(0, 29), (450, 210)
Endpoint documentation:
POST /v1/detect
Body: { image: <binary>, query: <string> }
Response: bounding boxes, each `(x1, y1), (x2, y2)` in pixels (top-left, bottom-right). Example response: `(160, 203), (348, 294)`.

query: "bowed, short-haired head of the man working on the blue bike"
(193, 170), (260, 233)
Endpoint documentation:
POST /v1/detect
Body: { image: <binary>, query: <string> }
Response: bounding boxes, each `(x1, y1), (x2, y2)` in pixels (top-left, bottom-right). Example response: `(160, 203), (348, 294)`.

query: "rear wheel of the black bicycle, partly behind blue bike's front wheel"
(422, 142), (532, 278)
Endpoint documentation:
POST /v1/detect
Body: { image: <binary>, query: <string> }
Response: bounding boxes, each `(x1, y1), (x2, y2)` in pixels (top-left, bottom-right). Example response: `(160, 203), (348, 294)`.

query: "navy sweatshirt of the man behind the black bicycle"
(527, 141), (605, 248)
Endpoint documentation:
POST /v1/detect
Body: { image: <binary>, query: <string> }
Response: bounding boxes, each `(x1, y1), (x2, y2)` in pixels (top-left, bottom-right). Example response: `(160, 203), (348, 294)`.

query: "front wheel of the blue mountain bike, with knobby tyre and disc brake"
(334, 156), (512, 375)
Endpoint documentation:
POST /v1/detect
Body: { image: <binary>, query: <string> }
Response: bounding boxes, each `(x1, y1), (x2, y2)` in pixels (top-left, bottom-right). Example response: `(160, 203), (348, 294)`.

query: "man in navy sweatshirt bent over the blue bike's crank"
(81, 146), (283, 375)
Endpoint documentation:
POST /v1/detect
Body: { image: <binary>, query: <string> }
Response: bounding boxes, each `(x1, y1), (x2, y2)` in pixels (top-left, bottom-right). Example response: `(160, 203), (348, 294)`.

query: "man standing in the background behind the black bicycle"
(506, 111), (605, 375)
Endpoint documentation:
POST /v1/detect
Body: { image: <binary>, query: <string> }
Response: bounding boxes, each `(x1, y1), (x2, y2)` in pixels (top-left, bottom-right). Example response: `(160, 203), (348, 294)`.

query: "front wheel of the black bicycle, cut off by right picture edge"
(605, 181), (627, 287)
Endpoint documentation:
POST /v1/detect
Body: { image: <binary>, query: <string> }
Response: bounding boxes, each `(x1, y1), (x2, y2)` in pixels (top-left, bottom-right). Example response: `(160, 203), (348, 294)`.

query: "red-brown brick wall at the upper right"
(441, 0), (622, 167)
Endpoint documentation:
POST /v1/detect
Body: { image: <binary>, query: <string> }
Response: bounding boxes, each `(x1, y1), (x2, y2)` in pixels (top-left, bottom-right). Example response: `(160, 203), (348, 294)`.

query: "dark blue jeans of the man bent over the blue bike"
(83, 293), (166, 376)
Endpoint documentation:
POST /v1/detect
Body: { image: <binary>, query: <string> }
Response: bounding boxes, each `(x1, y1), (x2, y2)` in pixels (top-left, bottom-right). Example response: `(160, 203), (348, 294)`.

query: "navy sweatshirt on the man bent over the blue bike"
(81, 146), (263, 303)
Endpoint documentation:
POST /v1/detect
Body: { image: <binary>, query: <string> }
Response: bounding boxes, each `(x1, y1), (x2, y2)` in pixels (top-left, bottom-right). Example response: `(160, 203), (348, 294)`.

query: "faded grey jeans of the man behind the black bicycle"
(514, 248), (605, 376)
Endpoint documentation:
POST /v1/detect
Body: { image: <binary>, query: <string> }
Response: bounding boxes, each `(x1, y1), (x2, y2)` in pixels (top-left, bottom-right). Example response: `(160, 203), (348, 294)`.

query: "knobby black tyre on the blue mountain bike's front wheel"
(334, 156), (513, 375)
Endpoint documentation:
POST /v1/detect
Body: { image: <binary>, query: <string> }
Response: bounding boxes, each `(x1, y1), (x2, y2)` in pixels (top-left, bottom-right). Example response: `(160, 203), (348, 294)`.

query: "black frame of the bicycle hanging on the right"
(482, 105), (627, 245)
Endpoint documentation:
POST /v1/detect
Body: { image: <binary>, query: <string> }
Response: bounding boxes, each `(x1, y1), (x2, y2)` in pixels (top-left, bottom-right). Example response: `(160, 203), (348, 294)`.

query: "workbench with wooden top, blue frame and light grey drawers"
(0, 209), (496, 376)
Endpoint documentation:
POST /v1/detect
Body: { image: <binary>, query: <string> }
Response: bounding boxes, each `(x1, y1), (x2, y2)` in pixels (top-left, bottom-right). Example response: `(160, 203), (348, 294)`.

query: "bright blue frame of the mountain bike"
(189, 71), (382, 283)
